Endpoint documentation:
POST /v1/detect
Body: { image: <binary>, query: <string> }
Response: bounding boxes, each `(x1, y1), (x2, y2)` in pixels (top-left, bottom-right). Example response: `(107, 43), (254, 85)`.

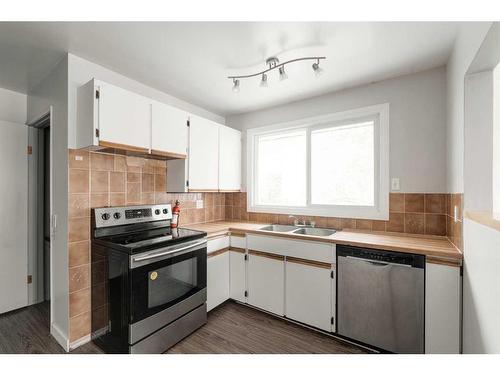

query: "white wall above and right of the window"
(226, 67), (446, 192)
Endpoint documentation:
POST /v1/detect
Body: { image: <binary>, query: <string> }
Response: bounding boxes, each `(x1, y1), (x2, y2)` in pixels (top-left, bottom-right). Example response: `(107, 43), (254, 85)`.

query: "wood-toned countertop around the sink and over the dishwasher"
(185, 221), (463, 266)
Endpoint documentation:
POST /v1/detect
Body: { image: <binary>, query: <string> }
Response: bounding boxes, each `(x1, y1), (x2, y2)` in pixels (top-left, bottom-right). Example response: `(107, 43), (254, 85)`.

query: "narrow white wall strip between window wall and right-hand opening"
(446, 22), (491, 193)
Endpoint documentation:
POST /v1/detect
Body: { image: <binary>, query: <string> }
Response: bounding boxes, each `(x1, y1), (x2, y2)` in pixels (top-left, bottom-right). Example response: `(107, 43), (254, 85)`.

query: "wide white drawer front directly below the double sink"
(247, 234), (335, 263)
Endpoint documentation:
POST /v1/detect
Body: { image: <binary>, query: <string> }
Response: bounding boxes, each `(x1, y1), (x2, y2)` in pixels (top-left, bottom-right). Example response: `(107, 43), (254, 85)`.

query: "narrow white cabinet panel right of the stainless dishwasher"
(425, 263), (461, 354)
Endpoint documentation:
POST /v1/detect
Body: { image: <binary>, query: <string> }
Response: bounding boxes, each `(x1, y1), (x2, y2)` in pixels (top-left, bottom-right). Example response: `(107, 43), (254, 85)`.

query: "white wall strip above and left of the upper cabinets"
(68, 54), (225, 148)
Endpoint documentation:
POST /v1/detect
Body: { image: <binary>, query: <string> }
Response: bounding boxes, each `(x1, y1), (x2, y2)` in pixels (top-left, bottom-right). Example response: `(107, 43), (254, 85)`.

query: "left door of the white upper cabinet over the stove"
(97, 82), (151, 152)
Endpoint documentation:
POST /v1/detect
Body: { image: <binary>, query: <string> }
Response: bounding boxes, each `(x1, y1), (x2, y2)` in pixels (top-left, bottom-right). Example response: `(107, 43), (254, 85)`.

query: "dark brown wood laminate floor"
(0, 301), (367, 354)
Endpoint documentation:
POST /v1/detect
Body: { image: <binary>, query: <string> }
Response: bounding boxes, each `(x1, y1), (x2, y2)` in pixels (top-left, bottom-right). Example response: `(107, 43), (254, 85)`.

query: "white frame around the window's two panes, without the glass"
(247, 103), (389, 220)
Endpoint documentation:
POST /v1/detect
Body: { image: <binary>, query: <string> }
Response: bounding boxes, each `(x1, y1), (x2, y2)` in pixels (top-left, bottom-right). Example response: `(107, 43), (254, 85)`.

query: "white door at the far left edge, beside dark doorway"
(0, 121), (28, 314)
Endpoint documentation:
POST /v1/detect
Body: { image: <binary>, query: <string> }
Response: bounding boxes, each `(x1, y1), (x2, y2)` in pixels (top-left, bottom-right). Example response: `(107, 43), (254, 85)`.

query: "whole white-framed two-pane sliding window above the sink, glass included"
(247, 104), (389, 219)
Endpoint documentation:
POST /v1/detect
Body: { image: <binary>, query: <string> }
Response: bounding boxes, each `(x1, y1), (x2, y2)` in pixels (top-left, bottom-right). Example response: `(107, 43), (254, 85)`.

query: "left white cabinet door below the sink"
(248, 251), (285, 316)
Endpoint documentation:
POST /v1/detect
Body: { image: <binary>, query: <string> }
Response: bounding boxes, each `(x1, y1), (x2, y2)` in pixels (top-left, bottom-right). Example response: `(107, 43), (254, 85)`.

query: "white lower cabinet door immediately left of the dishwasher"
(285, 258), (333, 331)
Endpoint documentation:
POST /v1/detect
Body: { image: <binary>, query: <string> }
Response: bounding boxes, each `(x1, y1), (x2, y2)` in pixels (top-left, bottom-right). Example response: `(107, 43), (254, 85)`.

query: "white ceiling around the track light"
(0, 22), (459, 115)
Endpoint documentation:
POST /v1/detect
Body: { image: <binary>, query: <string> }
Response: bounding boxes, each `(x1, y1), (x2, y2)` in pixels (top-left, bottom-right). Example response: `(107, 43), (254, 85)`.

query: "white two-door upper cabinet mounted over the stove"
(76, 79), (189, 159)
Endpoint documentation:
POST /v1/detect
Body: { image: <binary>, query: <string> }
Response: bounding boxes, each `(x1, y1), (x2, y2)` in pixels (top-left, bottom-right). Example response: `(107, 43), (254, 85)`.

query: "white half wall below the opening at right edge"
(463, 218), (500, 354)
